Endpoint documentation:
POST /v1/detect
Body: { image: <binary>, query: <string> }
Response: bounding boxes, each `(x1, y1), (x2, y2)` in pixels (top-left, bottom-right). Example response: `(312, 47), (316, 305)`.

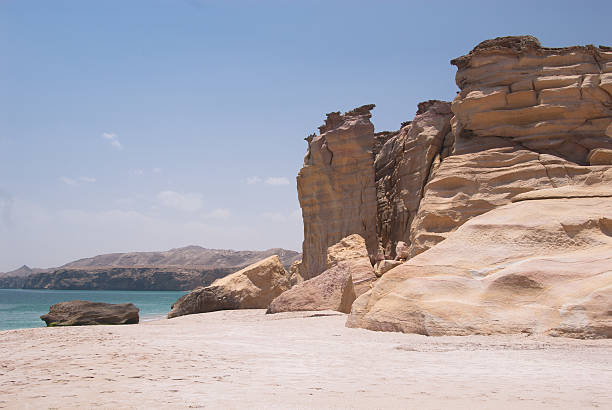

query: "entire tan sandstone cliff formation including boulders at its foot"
(40, 36), (612, 338)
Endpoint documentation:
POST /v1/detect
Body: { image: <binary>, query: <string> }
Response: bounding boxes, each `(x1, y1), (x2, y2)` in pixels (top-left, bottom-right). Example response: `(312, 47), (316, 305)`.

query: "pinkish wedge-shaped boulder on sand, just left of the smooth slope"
(266, 262), (357, 313)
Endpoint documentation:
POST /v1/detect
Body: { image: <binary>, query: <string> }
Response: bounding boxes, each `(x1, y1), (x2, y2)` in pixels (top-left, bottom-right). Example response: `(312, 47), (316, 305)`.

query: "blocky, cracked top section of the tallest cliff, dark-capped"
(451, 36), (612, 165)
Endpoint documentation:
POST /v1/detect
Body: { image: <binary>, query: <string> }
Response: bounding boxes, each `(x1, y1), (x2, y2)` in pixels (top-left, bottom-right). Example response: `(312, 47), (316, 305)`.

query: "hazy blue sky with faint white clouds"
(0, 0), (612, 271)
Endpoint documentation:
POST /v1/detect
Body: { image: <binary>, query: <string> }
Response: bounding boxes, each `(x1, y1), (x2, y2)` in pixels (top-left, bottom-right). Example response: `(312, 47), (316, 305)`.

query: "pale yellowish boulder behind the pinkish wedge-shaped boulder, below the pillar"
(326, 234), (376, 296)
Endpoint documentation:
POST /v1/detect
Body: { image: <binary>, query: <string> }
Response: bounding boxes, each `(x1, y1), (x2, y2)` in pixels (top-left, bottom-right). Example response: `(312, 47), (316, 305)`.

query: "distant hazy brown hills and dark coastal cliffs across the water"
(0, 246), (301, 290)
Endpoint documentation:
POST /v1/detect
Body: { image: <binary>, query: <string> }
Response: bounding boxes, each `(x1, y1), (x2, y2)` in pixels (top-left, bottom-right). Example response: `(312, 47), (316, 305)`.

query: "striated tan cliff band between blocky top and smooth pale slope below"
(409, 146), (612, 257)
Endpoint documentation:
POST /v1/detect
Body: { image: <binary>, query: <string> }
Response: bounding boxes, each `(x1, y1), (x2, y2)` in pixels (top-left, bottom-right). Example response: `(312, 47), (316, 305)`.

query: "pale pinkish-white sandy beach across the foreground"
(0, 310), (612, 410)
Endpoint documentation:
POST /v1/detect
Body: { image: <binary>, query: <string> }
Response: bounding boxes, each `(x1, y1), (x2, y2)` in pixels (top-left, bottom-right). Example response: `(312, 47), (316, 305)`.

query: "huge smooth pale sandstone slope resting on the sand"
(347, 194), (612, 338)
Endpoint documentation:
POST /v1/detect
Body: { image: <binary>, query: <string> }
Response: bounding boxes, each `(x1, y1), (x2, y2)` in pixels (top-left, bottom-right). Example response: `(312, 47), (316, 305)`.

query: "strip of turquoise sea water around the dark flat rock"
(0, 289), (187, 330)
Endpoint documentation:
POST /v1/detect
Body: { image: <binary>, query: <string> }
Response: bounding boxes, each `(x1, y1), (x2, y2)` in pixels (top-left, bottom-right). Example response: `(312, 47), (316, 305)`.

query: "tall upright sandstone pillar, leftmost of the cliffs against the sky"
(297, 105), (378, 279)
